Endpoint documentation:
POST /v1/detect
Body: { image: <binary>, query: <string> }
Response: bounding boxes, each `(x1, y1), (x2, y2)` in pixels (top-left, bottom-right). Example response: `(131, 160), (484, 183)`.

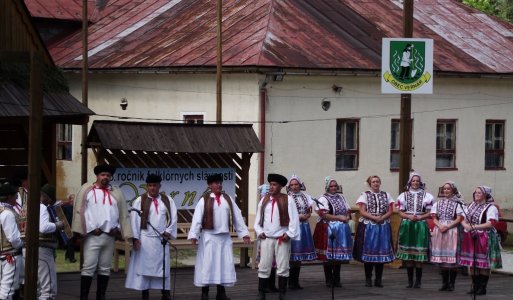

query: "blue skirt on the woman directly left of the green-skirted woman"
(353, 221), (395, 263)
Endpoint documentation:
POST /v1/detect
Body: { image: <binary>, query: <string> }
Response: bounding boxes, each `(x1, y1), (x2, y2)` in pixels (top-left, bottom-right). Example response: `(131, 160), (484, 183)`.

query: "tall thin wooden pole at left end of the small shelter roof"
(81, 0), (89, 184)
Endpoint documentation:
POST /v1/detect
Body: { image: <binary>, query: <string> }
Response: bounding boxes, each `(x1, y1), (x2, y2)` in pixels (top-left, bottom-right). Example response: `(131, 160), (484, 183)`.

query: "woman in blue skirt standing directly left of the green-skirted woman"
(353, 175), (394, 288)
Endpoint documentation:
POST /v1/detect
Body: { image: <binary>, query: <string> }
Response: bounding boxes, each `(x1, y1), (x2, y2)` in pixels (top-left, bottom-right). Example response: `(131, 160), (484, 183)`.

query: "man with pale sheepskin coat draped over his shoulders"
(72, 164), (132, 299)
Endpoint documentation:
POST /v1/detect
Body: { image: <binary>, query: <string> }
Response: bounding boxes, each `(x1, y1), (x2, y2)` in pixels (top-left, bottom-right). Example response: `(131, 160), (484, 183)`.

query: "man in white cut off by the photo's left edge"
(0, 183), (24, 299)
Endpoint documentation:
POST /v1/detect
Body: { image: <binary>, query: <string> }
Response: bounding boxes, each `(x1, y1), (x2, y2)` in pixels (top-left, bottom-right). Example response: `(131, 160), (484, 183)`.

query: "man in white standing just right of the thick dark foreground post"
(37, 184), (64, 300)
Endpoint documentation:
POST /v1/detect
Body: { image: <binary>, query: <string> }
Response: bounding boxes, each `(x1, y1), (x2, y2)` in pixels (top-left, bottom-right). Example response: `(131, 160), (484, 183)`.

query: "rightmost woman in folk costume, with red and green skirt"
(460, 186), (502, 295)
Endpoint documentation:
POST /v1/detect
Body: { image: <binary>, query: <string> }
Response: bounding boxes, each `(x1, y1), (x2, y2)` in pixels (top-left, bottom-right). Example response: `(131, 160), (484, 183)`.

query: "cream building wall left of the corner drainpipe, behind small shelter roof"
(57, 74), (261, 220)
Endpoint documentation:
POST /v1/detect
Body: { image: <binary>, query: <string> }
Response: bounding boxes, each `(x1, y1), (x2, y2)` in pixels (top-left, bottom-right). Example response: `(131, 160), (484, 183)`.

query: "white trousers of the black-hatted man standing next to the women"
(258, 238), (290, 278)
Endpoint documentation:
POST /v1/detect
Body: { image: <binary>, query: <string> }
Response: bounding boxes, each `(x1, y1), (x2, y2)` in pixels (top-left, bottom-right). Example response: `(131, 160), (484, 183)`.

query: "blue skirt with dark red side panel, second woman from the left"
(314, 221), (353, 261)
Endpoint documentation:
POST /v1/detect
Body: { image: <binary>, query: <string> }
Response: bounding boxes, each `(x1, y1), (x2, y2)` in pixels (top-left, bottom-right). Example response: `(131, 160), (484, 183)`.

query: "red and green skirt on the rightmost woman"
(460, 229), (502, 269)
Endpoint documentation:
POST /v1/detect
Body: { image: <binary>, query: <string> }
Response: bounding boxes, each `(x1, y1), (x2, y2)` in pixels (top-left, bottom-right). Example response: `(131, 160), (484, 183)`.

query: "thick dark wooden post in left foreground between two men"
(24, 52), (43, 299)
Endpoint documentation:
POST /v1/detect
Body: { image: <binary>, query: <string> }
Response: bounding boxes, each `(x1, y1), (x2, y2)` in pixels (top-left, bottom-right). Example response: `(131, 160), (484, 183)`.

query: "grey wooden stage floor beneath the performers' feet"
(57, 263), (513, 300)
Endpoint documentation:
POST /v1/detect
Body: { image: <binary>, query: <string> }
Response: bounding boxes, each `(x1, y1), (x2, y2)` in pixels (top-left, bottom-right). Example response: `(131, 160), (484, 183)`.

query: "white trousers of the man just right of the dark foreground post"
(37, 247), (57, 300)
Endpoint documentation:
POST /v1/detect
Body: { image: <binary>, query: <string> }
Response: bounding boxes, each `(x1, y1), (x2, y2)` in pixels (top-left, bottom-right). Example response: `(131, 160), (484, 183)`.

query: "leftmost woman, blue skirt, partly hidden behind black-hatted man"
(286, 175), (317, 290)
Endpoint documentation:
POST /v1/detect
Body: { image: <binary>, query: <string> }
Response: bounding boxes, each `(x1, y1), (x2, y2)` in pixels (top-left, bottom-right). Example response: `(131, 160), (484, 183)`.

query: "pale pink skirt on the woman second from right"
(431, 220), (460, 268)
